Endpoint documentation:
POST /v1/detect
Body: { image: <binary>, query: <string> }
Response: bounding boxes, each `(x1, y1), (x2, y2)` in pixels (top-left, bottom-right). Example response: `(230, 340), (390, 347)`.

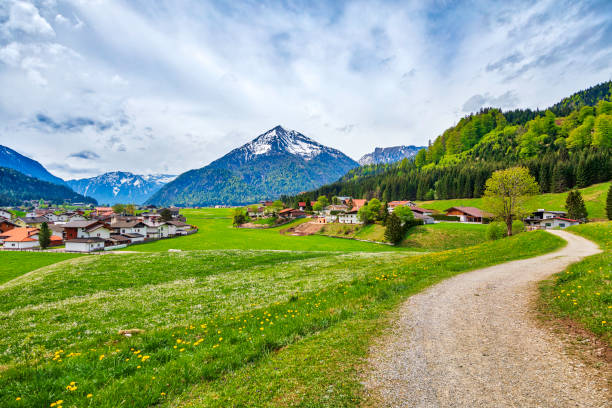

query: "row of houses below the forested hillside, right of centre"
(241, 197), (581, 231)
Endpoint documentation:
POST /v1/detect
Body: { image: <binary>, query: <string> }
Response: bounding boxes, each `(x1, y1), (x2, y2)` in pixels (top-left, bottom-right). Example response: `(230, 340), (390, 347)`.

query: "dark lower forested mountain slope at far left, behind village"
(0, 167), (97, 206)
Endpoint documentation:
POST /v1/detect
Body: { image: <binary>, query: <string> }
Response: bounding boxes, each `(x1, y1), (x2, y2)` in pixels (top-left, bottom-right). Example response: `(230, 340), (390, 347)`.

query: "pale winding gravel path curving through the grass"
(364, 231), (612, 408)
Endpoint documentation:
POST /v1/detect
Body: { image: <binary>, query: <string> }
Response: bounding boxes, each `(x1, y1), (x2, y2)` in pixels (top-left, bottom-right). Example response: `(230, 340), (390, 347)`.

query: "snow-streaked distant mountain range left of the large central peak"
(67, 171), (176, 205)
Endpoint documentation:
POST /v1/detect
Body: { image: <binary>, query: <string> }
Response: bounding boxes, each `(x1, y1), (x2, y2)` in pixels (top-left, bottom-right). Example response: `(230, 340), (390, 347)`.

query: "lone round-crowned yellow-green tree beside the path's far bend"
(484, 167), (540, 236)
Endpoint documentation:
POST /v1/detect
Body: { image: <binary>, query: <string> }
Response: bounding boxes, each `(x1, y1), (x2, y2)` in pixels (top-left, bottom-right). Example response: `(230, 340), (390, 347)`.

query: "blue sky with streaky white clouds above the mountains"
(0, 0), (612, 179)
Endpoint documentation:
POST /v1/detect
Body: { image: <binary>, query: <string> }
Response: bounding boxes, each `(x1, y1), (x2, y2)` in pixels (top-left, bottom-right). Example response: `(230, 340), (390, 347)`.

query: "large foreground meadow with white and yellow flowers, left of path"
(0, 232), (562, 407)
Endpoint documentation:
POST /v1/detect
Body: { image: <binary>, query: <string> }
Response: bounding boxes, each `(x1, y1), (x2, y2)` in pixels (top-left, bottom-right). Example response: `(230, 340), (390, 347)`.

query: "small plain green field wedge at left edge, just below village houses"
(0, 251), (80, 285)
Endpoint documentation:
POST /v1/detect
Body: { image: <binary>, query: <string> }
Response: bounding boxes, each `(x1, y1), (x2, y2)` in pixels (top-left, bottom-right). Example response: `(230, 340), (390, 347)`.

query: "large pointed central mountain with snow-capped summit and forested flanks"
(147, 126), (358, 206)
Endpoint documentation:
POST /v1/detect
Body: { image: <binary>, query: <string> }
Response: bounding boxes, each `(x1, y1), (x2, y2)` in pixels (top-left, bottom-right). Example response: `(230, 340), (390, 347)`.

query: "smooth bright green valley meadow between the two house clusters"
(128, 209), (397, 252)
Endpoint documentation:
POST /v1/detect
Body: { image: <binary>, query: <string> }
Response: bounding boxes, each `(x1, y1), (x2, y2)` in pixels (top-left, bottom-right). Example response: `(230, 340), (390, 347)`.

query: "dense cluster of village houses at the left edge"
(0, 203), (197, 253)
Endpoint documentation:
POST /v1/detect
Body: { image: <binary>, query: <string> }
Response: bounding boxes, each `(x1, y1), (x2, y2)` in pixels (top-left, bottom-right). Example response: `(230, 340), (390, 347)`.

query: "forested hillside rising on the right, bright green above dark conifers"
(283, 82), (612, 203)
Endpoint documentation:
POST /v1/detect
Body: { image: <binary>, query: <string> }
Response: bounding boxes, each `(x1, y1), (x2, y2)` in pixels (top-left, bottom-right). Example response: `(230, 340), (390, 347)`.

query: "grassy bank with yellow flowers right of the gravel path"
(541, 221), (612, 345)
